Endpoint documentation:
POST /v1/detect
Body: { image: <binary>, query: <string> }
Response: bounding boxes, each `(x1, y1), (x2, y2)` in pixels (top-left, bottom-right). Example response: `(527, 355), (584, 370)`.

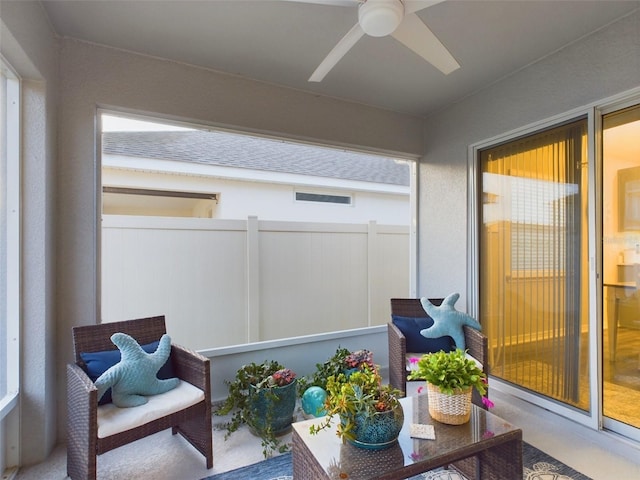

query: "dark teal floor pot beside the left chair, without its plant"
(248, 380), (297, 436)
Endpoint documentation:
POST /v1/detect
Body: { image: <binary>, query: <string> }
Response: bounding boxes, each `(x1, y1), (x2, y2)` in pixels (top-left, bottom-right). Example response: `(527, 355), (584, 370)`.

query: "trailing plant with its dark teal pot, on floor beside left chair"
(214, 361), (297, 457)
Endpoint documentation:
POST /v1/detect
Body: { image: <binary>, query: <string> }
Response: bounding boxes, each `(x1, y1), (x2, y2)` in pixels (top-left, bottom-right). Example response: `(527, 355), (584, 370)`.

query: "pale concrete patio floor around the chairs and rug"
(11, 382), (640, 480)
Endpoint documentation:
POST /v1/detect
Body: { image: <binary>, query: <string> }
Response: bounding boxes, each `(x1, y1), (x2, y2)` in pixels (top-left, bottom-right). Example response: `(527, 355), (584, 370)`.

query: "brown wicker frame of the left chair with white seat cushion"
(67, 316), (213, 480)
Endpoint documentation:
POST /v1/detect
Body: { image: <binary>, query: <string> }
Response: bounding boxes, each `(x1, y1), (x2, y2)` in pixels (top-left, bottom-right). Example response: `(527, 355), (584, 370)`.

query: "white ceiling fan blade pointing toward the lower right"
(391, 13), (460, 75)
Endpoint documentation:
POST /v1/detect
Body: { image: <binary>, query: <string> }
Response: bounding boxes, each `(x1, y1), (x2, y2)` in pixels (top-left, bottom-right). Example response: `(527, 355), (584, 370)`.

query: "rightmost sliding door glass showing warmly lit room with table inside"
(602, 106), (640, 433)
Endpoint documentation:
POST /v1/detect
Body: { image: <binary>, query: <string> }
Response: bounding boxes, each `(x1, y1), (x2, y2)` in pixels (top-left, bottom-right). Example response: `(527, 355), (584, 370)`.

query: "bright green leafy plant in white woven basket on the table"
(407, 349), (490, 425)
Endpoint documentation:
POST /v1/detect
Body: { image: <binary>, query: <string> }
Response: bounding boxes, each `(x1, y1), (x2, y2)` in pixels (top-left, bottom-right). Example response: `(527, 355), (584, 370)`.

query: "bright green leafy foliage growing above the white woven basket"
(408, 349), (487, 395)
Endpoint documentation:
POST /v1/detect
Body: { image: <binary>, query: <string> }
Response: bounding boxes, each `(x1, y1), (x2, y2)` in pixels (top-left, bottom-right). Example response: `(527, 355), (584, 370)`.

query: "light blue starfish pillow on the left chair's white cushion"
(95, 333), (180, 407)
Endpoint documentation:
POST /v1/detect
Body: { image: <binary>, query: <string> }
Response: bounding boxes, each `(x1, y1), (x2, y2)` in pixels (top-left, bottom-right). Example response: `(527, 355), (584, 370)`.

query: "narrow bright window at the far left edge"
(0, 58), (20, 473)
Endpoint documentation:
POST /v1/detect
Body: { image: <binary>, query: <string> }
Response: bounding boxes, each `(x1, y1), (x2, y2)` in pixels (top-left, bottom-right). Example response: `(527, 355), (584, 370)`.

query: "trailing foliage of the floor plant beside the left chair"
(214, 361), (296, 457)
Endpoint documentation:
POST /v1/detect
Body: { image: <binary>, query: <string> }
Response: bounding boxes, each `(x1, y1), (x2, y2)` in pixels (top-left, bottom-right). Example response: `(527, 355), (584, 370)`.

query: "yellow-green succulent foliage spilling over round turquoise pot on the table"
(309, 362), (402, 440)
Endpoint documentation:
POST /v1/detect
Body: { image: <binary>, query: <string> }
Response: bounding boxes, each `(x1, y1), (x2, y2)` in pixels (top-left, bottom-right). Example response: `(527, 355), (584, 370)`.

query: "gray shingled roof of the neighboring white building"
(102, 130), (409, 185)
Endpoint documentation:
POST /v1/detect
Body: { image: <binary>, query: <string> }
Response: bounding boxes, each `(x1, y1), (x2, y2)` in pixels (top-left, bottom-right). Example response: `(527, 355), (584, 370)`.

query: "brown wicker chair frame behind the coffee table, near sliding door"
(387, 298), (489, 408)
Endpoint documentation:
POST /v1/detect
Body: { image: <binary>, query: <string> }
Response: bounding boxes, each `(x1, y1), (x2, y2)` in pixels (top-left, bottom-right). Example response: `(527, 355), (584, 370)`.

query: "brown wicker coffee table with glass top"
(293, 395), (523, 480)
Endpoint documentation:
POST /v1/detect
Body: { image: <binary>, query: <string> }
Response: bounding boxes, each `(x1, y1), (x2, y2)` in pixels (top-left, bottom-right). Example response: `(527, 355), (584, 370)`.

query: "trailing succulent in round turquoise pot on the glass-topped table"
(310, 357), (404, 449)
